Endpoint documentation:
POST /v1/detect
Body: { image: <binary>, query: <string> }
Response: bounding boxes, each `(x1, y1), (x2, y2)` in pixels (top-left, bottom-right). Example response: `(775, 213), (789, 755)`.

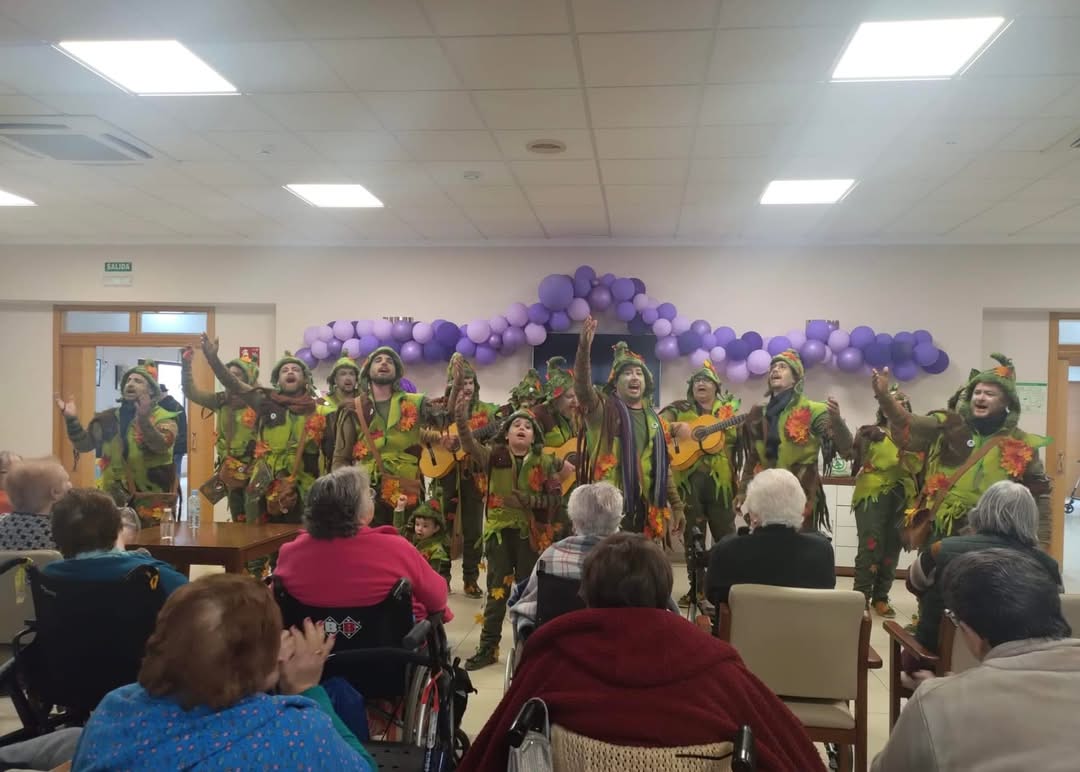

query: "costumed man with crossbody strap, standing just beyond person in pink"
(332, 346), (448, 530)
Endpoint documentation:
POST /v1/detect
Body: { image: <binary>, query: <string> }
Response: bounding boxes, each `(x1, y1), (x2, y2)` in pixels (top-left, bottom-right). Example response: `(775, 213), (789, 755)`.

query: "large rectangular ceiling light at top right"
(833, 16), (1008, 81)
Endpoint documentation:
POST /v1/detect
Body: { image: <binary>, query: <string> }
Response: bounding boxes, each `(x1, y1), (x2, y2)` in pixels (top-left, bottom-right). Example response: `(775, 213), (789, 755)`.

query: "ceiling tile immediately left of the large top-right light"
(708, 27), (850, 83)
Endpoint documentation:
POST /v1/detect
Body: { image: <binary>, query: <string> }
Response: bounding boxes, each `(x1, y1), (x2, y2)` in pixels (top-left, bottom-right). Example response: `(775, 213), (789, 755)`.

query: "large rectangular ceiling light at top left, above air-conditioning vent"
(55, 40), (239, 96)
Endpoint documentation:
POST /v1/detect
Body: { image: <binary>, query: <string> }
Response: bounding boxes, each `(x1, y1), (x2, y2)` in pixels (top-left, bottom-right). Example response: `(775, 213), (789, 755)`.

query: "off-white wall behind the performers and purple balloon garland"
(0, 246), (1080, 452)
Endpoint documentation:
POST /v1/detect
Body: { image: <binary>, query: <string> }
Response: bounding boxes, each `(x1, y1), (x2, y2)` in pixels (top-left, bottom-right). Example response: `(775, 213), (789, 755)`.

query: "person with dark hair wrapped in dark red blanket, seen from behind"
(458, 532), (824, 772)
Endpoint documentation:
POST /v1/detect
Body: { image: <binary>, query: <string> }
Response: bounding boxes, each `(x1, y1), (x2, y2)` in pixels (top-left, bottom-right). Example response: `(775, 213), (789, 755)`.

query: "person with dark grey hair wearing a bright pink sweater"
(274, 466), (454, 621)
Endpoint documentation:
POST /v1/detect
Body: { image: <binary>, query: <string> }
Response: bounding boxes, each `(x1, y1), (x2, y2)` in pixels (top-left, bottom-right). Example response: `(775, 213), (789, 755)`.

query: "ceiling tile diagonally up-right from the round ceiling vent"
(589, 85), (701, 128)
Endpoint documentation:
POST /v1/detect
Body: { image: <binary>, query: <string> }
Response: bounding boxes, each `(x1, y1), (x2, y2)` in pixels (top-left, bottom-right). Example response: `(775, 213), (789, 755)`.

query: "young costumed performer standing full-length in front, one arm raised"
(453, 360), (573, 671)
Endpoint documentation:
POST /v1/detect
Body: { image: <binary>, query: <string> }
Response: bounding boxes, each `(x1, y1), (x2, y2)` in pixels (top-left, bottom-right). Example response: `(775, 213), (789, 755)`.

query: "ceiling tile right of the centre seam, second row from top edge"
(578, 30), (713, 85)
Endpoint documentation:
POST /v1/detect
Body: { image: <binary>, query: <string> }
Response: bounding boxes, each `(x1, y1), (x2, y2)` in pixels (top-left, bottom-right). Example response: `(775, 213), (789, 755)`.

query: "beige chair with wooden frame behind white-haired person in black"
(720, 584), (870, 771)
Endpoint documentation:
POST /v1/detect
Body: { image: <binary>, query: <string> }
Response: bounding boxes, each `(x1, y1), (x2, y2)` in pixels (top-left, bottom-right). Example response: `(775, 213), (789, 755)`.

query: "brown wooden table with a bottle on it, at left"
(127, 523), (300, 574)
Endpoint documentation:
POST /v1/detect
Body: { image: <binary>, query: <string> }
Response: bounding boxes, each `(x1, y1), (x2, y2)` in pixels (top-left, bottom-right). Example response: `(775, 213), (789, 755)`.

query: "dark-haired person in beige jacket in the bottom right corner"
(872, 548), (1080, 772)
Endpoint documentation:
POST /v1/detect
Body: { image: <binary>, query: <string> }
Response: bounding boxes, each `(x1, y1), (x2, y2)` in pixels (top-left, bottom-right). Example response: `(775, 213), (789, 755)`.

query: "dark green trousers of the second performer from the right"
(854, 485), (906, 604)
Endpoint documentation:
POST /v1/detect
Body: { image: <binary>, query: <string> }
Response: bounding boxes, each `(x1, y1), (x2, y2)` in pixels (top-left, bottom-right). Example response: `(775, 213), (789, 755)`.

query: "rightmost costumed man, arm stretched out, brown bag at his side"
(873, 354), (1051, 550)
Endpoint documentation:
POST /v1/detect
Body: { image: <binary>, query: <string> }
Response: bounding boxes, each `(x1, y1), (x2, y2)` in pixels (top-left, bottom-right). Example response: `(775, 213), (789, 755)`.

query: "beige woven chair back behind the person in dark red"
(551, 724), (733, 772)
